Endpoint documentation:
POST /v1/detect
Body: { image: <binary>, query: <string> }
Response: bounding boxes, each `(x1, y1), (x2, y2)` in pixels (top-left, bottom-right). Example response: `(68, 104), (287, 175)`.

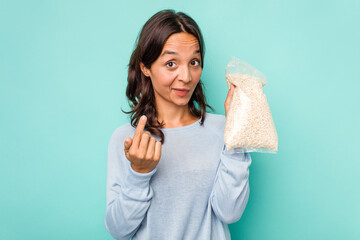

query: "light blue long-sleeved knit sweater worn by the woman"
(104, 113), (251, 240)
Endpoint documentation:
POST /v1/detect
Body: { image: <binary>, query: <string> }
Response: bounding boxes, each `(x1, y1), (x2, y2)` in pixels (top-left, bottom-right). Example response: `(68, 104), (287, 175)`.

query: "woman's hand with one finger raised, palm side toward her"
(124, 116), (161, 173)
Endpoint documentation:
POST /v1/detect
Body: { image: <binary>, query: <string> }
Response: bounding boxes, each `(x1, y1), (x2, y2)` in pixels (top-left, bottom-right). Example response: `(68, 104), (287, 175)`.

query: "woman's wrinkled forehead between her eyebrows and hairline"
(162, 32), (199, 52)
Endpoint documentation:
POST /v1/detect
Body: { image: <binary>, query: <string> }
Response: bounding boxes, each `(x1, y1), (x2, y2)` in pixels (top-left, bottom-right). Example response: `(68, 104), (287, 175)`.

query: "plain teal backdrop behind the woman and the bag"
(0, 0), (360, 240)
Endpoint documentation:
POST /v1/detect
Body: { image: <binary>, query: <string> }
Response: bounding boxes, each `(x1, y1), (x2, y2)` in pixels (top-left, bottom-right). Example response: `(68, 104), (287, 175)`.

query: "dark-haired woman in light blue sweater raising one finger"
(105, 10), (251, 240)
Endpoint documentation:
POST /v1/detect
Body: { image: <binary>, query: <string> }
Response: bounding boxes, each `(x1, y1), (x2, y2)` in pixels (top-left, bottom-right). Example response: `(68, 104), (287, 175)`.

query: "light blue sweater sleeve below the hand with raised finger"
(104, 129), (157, 240)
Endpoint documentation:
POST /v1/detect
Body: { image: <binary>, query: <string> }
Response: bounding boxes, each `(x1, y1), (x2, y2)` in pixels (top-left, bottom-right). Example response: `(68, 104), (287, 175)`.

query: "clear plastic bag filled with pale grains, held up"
(224, 57), (278, 153)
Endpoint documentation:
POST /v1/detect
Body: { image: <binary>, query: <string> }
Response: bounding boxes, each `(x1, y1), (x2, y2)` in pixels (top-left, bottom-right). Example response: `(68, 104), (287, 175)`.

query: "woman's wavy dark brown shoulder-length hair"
(122, 9), (214, 144)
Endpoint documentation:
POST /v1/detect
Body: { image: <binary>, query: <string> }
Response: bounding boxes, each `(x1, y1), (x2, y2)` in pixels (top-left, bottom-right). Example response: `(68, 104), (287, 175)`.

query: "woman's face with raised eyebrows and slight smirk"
(141, 32), (202, 109)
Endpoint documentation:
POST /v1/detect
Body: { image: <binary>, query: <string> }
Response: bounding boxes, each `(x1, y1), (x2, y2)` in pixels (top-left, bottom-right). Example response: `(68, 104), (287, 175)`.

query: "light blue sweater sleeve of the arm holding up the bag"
(210, 145), (252, 224)
